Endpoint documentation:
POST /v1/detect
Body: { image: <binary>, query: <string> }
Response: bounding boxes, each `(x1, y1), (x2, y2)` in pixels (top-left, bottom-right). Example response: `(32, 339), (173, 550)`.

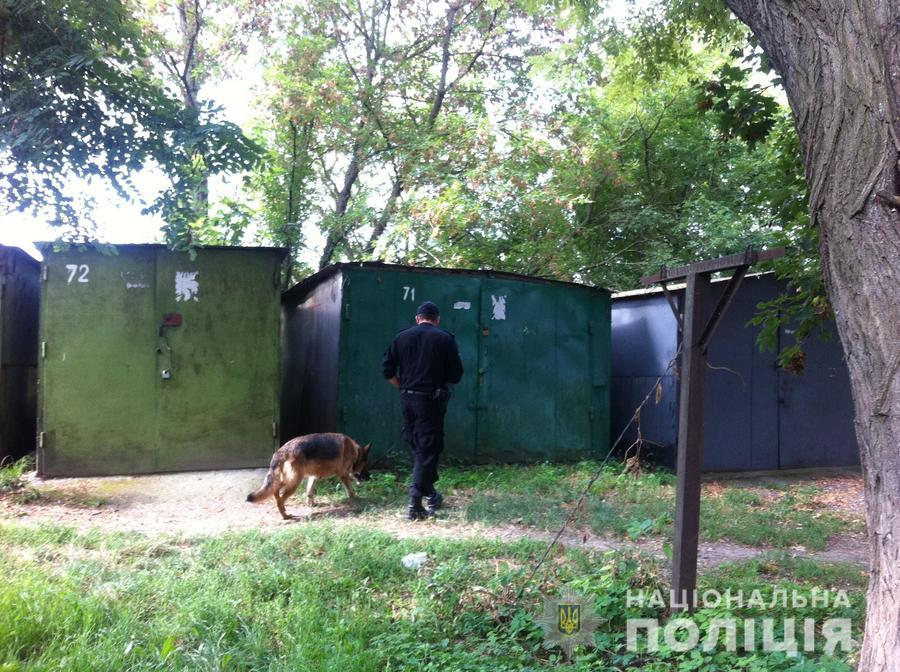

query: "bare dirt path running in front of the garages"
(0, 469), (866, 568)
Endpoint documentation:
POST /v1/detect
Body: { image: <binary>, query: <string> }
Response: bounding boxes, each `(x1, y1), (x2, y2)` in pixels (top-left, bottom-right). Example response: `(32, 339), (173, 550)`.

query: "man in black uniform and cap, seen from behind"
(381, 301), (463, 520)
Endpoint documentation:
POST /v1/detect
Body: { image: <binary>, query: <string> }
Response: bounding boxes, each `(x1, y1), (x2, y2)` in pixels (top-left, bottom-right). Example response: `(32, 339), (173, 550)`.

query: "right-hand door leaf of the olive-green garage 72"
(154, 250), (280, 471)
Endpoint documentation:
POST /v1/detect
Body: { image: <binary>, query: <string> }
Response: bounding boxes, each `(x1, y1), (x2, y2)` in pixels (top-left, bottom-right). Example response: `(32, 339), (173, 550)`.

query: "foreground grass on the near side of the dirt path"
(0, 521), (862, 672)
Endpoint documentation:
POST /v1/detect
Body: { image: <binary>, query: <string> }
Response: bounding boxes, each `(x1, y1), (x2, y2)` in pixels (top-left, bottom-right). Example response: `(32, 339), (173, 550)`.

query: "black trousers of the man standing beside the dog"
(400, 394), (448, 497)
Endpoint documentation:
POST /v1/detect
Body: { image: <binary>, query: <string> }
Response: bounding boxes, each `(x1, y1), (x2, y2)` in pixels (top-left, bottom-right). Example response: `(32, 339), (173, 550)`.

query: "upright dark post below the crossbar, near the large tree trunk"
(671, 273), (710, 611)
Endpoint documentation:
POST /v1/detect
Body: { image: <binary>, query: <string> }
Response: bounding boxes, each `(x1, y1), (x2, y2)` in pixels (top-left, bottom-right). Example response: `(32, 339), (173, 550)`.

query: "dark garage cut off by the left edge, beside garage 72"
(0, 245), (40, 462)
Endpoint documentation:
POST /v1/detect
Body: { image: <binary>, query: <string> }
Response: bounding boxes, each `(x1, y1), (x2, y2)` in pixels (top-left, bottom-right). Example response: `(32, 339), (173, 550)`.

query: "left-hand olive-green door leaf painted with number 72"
(38, 248), (158, 476)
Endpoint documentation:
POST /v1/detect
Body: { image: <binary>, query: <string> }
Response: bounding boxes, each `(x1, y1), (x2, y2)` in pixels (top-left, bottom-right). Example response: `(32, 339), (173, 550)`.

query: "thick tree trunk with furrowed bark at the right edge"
(726, 0), (900, 672)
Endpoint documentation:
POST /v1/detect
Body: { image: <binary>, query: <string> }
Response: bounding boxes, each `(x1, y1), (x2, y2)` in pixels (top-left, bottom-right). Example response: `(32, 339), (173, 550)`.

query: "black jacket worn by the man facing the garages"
(381, 322), (463, 392)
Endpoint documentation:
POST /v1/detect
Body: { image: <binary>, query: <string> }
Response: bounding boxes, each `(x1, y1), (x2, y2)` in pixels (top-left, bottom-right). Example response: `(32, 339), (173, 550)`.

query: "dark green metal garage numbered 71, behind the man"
(282, 263), (610, 463)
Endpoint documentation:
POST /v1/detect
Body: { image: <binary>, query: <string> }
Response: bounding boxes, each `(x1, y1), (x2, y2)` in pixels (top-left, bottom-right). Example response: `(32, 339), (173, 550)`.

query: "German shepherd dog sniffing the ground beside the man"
(247, 434), (372, 520)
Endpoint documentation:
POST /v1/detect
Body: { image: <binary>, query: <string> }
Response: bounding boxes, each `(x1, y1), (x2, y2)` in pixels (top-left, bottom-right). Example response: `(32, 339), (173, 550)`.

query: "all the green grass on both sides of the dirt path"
(0, 454), (866, 672)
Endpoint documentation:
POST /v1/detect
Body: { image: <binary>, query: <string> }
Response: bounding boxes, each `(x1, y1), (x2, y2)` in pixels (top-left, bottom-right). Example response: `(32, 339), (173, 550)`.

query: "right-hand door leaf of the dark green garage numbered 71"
(478, 279), (591, 461)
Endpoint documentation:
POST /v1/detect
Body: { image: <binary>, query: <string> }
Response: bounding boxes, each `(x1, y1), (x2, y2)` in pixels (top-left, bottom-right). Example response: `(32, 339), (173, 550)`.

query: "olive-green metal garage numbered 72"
(38, 245), (285, 476)
